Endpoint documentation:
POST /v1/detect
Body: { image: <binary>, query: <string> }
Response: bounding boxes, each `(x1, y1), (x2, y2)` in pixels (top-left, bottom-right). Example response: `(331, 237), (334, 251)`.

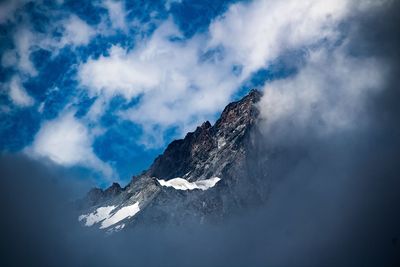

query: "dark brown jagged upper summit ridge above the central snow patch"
(146, 89), (262, 179)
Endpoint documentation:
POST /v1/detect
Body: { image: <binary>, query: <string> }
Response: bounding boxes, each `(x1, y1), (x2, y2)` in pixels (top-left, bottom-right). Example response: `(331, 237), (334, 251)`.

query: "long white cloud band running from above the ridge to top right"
(78, 0), (386, 149)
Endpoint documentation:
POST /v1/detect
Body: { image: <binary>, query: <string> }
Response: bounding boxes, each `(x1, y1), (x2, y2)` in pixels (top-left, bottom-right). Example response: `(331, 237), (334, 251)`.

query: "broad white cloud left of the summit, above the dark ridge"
(78, 20), (241, 146)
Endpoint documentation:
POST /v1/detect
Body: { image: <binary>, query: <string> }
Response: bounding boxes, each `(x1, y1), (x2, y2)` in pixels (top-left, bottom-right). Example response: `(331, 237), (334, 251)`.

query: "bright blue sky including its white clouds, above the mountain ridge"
(0, 0), (385, 186)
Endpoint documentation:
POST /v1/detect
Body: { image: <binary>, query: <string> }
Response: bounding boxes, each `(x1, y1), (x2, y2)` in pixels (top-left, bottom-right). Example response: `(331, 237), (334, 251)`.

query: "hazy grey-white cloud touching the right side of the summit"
(260, 44), (386, 138)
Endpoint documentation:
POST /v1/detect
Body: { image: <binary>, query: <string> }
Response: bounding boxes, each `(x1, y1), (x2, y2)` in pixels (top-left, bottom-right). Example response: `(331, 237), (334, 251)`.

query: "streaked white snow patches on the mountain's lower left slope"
(78, 202), (140, 229)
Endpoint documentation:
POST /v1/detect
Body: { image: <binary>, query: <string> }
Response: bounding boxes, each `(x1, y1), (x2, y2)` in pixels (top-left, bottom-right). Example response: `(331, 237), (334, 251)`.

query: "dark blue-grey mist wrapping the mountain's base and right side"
(0, 3), (400, 266)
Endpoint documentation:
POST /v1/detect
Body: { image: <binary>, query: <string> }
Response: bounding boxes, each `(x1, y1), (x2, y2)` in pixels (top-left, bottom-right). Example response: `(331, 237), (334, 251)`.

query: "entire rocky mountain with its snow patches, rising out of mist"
(79, 90), (268, 232)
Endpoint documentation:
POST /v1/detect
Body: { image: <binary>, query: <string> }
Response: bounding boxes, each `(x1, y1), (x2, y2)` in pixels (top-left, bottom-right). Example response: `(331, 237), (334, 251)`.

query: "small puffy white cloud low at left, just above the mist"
(26, 112), (113, 177)
